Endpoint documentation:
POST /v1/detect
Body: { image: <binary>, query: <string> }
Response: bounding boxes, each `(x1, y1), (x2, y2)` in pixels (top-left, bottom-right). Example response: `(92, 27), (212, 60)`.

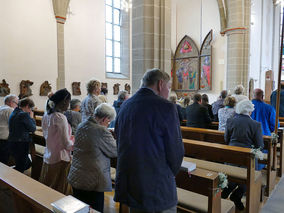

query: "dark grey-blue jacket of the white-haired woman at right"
(225, 114), (263, 148)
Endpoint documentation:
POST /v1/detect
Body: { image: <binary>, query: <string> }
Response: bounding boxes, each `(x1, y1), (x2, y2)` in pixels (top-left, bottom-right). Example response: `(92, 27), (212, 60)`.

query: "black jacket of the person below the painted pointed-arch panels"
(186, 103), (211, 128)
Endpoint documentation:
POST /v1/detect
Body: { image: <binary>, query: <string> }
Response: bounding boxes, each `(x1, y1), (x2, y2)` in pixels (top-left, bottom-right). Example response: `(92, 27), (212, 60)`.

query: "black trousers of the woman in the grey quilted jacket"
(72, 187), (104, 212)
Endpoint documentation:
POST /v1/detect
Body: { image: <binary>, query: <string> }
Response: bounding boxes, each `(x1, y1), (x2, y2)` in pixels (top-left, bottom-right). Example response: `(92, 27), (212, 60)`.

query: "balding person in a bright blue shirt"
(251, 89), (276, 136)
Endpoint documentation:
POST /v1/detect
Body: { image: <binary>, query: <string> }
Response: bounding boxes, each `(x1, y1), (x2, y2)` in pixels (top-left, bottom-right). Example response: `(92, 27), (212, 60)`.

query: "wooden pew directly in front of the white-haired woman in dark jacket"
(181, 127), (277, 196)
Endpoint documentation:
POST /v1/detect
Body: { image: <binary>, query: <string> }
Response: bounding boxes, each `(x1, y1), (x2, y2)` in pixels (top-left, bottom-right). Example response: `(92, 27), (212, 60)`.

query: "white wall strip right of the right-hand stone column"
(249, 0), (279, 90)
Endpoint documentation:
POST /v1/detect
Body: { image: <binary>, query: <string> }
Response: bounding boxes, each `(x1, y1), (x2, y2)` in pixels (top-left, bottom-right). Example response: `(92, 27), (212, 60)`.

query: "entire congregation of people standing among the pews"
(0, 72), (284, 213)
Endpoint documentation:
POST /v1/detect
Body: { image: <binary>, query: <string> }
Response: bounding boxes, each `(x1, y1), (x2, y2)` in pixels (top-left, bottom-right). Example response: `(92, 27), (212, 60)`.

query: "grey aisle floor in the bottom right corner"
(260, 177), (284, 213)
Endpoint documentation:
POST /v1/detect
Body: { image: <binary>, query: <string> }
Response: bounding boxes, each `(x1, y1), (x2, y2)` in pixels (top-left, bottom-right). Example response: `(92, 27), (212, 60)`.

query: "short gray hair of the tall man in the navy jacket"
(141, 68), (170, 87)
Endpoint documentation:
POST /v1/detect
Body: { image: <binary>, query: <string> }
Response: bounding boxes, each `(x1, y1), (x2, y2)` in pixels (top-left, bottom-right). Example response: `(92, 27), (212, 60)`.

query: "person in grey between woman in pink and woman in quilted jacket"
(64, 99), (82, 135)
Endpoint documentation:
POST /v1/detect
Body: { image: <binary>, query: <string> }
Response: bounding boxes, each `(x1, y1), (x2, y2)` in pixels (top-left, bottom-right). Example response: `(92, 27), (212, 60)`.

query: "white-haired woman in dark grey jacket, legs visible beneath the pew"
(222, 100), (263, 210)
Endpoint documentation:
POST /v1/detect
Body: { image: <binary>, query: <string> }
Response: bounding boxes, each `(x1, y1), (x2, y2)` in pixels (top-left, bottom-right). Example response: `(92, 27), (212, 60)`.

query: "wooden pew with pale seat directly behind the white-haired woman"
(183, 139), (261, 213)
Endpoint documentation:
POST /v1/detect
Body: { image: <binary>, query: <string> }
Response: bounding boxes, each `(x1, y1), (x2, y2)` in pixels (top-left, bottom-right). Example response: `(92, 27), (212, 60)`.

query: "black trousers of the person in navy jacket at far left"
(11, 141), (32, 173)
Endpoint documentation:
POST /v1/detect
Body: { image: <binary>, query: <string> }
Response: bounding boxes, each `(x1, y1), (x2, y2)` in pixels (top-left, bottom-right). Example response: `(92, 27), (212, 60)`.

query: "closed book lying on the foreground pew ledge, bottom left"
(51, 195), (90, 213)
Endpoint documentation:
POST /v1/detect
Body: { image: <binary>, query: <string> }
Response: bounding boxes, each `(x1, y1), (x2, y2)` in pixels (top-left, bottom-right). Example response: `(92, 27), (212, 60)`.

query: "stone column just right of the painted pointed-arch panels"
(223, 0), (251, 95)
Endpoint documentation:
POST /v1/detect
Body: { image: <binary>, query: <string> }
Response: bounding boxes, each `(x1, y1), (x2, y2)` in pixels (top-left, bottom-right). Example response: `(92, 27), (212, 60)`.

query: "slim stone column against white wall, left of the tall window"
(52, 0), (70, 90)
